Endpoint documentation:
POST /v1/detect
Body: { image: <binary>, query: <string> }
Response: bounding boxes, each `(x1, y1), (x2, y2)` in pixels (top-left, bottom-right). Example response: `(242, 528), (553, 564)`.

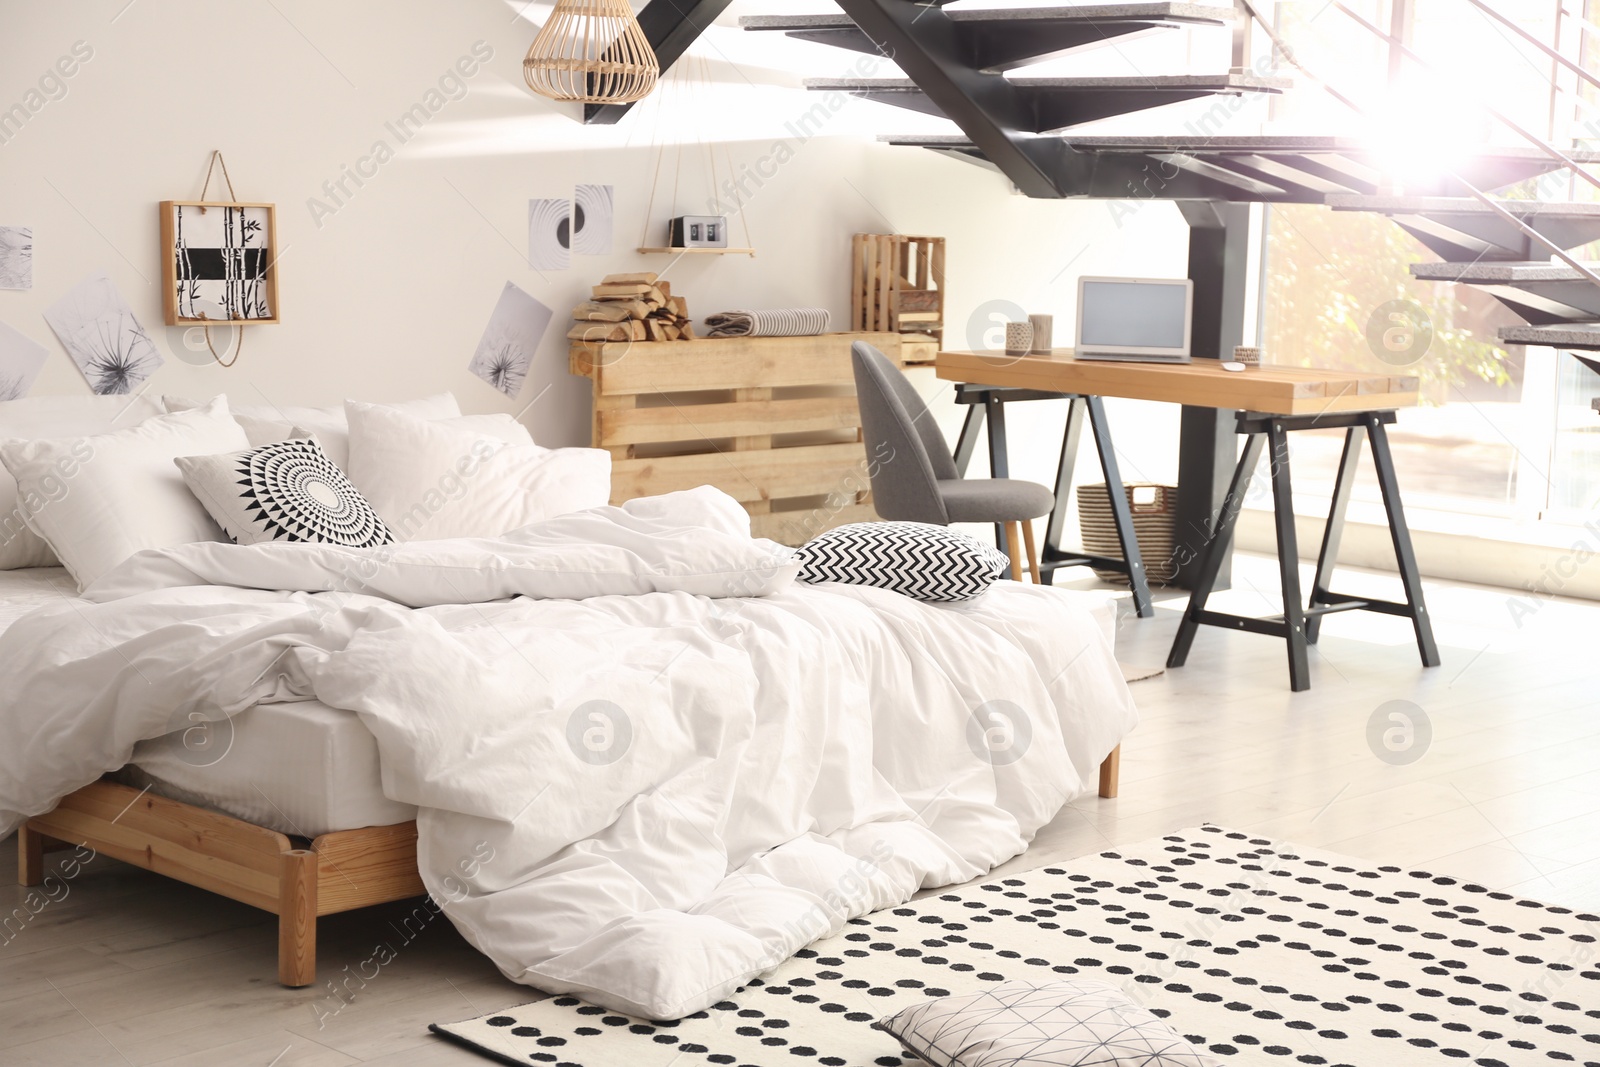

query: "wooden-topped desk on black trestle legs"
(936, 349), (1440, 691)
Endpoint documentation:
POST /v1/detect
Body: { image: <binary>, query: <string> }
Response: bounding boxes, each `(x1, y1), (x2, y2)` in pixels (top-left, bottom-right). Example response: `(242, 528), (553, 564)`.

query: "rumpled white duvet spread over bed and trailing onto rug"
(0, 490), (1136, 1019)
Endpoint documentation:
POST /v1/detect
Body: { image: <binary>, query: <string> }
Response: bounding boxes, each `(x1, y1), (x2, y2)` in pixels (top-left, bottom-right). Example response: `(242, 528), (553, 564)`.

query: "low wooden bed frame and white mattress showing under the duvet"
(0, 568), (426, 987)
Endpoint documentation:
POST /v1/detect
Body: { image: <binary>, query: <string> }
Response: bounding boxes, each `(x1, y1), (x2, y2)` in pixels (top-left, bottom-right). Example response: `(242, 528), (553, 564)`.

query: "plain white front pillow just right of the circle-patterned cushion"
(344, 402), (611, 541)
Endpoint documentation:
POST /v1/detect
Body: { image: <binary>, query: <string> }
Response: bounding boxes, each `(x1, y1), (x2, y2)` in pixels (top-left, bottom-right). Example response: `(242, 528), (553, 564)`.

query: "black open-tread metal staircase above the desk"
(742, 0), (1600, 388)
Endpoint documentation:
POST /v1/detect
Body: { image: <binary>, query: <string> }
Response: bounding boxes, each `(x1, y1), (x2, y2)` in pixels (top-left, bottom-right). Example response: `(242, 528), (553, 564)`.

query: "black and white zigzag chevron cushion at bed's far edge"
(798, 523), (1010, 601)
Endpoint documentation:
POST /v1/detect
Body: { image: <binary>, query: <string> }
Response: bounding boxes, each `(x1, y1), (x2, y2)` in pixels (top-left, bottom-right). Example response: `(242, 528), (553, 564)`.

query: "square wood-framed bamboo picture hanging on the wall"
(162, 200), (278, 326)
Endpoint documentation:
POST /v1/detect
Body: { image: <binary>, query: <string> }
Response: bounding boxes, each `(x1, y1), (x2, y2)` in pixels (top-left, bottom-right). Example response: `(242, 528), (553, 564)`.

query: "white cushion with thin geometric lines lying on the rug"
(872, 979), (1221, 1067)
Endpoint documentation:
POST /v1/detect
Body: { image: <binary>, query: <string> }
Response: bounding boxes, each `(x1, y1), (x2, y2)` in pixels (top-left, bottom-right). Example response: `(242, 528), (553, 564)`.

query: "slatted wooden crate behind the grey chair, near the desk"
(850, 234), (944, 363)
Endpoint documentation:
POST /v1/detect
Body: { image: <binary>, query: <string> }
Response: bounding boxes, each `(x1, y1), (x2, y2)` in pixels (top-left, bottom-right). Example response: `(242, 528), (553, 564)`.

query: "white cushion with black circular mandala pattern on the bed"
(176, 437), (394, 549)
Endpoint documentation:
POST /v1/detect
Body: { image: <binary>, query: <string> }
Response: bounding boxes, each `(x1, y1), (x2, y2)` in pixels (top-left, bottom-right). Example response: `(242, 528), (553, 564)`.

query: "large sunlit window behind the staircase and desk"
(1262, 0), (1600, 533)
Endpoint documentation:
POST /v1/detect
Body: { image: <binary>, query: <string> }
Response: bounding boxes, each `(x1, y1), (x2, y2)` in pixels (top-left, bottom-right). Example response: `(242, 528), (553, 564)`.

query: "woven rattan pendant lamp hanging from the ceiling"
(522, 0), (661, 104)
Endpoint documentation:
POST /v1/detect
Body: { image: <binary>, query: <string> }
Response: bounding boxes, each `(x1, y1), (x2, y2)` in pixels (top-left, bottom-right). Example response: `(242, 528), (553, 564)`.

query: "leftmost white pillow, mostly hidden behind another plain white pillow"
(0, 395), (162, 571)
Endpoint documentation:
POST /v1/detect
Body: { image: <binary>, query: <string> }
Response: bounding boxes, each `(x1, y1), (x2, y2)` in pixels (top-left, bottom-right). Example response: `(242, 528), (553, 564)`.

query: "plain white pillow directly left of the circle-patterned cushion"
(0, 397), (250, 589)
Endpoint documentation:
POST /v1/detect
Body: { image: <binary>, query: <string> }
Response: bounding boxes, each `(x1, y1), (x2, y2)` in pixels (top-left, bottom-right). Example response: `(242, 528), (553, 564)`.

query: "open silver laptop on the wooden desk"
(1074, 278), (1195, 363)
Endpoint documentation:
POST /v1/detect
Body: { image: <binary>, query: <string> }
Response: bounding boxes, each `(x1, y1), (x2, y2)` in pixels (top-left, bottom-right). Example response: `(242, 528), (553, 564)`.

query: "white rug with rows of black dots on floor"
(434, 827), (1600, 1067)
